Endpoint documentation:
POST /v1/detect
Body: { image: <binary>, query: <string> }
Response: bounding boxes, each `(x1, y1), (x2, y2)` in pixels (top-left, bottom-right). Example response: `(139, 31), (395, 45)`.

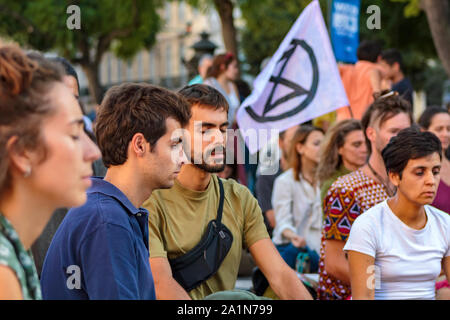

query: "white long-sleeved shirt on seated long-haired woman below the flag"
(272, 169), (323, 253)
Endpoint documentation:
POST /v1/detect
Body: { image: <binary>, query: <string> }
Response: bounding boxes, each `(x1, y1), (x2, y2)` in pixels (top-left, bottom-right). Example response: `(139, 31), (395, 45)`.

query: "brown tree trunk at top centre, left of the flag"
(214, 0), (238, 70)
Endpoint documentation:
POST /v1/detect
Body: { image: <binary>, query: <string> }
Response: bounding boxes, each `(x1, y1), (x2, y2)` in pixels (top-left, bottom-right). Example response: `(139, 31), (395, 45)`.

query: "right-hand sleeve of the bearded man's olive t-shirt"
(241, 187), (270, 248)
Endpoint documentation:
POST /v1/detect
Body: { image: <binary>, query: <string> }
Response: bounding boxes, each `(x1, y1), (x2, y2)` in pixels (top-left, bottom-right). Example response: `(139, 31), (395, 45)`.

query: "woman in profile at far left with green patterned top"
(0, 47), (100, 300)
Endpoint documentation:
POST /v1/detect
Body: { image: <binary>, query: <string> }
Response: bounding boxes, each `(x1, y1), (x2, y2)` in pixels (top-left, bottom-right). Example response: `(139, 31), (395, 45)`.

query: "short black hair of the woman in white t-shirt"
(381, 125), (442, 179)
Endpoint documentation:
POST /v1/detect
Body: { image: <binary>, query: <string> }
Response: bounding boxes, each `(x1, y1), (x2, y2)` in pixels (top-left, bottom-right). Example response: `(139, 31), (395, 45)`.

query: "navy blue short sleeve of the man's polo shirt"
(80, 223), (140, 300)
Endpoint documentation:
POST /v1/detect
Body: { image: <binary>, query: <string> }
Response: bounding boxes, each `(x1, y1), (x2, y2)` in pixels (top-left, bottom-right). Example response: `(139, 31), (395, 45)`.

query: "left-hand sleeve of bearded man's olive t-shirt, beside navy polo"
(143, 195), (167, 258)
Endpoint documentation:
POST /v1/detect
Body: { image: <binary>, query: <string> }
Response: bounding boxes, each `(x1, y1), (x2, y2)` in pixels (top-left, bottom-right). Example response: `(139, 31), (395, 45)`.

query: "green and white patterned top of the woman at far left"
(0, 213), (42, 300)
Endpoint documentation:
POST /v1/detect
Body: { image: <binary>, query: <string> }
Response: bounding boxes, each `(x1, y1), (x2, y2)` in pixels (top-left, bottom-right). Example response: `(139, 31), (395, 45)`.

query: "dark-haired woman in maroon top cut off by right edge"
(418, 107), (450, 214)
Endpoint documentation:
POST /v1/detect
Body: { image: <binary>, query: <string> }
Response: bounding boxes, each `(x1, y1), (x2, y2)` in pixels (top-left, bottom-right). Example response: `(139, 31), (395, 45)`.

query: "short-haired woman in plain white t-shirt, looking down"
(344, 127), (450, 300)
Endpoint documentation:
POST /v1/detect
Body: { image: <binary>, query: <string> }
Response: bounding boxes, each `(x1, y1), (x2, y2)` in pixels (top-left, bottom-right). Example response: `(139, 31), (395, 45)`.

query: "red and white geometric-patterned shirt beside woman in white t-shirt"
(317, 170), (388, 300)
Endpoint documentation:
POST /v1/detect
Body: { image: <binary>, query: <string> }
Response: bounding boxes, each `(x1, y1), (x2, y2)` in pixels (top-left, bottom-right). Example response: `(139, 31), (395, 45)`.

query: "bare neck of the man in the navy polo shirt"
(104, 163), (154, 208)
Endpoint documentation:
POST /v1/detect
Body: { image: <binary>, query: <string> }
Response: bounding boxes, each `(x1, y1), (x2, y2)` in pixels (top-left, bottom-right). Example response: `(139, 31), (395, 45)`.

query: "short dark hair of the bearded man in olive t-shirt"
(178, 84), (229, 113)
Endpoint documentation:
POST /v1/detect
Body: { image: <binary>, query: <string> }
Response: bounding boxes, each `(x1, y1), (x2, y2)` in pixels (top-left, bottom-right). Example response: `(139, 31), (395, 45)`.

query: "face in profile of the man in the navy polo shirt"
(146, 118), (186, 189)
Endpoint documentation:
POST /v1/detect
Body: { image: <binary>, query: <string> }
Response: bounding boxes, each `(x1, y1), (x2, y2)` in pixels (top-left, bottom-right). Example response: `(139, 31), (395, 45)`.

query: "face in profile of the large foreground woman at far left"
(27, 82), (100, 207)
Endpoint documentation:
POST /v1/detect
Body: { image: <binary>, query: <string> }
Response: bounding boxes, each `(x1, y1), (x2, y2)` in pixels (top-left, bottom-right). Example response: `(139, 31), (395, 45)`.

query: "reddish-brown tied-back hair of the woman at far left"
(0, 46), (64, 195)
